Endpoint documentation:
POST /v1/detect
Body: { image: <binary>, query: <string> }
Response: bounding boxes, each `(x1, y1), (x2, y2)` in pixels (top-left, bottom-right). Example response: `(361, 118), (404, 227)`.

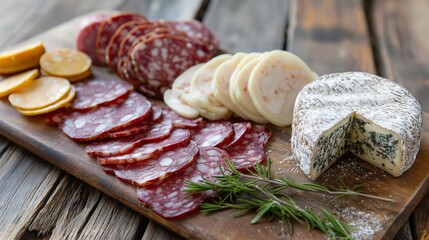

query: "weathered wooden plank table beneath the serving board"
(0, 0), (429, 239)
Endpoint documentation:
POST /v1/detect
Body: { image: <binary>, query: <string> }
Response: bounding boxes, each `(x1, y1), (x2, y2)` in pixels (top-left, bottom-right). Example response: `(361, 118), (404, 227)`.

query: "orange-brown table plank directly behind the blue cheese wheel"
(287, 0), (375, 75)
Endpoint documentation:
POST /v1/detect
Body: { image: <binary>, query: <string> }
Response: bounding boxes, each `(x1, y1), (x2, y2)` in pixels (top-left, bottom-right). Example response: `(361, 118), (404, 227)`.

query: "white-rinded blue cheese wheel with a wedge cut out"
(291, 72), (423, 179)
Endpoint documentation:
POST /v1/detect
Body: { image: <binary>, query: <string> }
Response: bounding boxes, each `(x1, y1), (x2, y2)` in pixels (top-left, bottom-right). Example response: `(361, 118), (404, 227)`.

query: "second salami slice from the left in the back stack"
(95, 13), (147, 65)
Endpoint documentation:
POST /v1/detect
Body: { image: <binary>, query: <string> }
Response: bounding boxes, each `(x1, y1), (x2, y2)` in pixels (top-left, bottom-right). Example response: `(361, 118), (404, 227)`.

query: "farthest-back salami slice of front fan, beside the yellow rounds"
(72, 76), (133, 110)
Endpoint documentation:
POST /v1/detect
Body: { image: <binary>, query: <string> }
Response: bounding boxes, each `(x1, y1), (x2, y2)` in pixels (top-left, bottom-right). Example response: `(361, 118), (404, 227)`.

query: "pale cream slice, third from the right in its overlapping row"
(212, 53), (247, 119)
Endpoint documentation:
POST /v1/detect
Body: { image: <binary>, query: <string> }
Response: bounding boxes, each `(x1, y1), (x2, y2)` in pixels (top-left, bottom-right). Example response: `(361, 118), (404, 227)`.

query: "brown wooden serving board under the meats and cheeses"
(0, 12), (429, 239)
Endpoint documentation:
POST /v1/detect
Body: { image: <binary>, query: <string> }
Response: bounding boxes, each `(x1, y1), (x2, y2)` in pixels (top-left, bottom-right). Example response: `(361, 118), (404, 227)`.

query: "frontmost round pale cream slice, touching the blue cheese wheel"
(248, 50), (315, 127)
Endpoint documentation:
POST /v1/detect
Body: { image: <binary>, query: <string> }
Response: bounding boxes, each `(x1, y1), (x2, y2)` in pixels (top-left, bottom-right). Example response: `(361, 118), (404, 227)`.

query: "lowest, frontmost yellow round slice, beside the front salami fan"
(9, 77), (71, 110)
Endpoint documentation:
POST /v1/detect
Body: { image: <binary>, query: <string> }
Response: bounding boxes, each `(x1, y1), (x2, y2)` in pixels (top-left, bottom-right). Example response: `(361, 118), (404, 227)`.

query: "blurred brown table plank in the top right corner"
(371, 0), (429, 111)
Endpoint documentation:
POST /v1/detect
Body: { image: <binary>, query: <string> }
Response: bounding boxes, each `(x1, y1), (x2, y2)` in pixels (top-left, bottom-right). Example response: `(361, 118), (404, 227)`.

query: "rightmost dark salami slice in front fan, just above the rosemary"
(228, 125), (271, 170)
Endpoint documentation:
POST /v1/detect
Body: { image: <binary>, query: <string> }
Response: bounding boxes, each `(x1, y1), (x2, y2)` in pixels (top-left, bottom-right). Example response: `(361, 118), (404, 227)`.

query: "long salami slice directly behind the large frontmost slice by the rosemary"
(103, 141), (198, 187)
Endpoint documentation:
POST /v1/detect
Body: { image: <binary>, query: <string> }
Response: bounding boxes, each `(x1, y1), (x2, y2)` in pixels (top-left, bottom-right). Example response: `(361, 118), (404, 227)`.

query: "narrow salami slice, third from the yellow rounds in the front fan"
(85, 117), (173, 157)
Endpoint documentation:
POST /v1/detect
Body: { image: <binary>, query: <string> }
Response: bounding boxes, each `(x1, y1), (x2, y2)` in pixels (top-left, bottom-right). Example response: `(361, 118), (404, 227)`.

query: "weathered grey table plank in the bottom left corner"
(0, 145), (61, 239)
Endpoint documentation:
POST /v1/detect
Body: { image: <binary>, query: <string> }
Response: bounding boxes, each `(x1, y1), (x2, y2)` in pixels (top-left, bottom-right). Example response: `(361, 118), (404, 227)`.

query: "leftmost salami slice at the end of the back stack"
(76, 13), (112, 65)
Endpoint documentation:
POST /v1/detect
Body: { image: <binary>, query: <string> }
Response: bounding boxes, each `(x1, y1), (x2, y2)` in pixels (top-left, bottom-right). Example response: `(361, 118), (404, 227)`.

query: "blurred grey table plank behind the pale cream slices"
(203, 0), (289, 52)
